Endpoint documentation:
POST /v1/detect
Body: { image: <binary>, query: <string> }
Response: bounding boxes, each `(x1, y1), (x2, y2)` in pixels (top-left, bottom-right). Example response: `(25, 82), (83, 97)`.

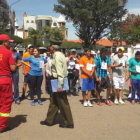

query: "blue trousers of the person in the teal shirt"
(132, 79), (140, 102)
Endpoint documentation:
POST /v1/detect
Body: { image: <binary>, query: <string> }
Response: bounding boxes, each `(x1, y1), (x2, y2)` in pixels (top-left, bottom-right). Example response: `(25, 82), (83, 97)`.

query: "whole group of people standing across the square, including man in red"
(0, 34), (140, 132)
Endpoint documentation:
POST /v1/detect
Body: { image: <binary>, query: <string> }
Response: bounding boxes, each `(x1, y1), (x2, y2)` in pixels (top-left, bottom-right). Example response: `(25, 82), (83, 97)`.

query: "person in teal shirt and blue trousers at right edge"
(129, 51), (140, 104)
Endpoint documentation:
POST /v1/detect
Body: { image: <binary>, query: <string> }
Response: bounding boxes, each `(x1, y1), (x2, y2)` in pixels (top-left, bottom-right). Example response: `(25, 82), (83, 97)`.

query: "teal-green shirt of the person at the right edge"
(129, 57), (140, 80)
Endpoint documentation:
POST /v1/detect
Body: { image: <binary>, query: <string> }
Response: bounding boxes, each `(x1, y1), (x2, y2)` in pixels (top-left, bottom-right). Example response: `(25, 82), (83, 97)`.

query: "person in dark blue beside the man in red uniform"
(10, 44), (22, 104)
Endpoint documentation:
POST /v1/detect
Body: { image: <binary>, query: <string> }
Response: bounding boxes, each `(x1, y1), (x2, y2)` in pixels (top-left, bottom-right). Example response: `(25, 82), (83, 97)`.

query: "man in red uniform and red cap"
(0, 34), (16, 133)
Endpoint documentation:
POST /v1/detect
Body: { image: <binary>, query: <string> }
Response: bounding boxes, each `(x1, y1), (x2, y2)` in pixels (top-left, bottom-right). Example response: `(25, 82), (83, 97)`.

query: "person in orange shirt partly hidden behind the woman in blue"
(21, 46), (34, 99)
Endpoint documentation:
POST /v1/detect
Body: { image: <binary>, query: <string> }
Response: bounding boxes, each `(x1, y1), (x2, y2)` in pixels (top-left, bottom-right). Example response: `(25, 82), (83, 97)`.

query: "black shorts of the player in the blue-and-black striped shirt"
(95, 77), (111, 91)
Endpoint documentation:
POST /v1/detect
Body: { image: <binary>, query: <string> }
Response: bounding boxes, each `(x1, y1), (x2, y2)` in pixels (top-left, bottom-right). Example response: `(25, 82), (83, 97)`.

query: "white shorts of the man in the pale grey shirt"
(113, 77), (125, 89)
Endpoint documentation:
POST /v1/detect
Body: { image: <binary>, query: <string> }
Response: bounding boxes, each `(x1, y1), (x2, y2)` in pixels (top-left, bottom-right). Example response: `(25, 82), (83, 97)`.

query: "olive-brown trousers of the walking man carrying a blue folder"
(45, 92), (73, 125)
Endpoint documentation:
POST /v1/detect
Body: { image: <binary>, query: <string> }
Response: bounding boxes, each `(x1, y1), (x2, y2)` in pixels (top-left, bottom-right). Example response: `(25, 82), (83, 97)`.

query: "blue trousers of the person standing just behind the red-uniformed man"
(12, 71), (19, 102)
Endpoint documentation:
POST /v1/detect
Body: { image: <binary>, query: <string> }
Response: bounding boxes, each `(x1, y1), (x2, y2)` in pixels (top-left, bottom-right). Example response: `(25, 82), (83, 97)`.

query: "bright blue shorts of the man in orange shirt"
(82, 79), (94, 91)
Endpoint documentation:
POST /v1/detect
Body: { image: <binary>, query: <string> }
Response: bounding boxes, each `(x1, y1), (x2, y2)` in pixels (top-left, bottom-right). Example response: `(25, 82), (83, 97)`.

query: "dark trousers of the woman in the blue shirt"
(29, 75), (43, 100)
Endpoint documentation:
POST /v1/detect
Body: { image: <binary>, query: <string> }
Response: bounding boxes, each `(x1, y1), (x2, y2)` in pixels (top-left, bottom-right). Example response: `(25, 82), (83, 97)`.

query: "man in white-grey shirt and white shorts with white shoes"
(111, 48), (129, 104)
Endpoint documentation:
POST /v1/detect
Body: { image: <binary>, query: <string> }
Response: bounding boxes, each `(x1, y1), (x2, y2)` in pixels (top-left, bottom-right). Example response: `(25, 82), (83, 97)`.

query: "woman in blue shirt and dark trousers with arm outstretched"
(23, 48), (47, 106)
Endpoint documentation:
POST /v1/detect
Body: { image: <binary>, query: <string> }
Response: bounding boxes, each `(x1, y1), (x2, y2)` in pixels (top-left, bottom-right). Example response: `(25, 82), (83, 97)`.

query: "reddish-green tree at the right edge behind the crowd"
(108, 14), (140, 45)
